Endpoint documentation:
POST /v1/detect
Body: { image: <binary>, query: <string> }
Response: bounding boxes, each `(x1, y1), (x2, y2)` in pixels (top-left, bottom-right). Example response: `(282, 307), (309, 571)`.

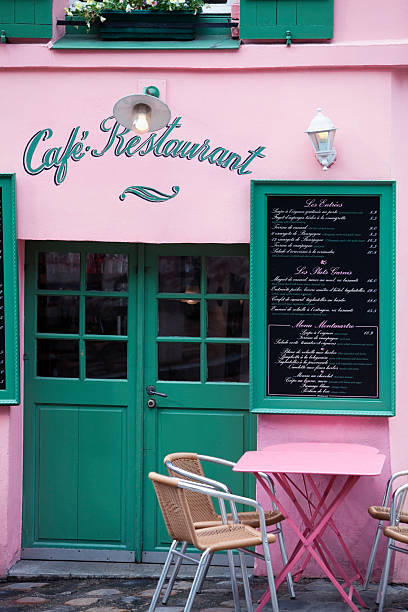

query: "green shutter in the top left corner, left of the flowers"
(0, 0), (52, 38)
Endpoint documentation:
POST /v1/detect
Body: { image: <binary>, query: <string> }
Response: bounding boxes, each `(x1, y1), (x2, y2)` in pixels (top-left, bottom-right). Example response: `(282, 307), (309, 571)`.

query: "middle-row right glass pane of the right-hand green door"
(207, 300), (249, 338)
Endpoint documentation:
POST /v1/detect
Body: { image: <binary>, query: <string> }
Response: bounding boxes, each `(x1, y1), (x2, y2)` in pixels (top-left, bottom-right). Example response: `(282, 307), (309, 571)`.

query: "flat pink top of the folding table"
(234, 442), (385, 476)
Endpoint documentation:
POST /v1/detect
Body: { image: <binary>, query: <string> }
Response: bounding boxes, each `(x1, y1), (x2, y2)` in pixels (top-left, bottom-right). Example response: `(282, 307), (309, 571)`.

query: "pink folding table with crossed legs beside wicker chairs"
(234, 442), (385, 612)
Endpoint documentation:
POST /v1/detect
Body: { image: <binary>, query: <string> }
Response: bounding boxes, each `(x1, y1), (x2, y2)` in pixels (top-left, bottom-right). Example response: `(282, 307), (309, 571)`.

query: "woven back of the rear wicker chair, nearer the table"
(163, 453), (220, 523)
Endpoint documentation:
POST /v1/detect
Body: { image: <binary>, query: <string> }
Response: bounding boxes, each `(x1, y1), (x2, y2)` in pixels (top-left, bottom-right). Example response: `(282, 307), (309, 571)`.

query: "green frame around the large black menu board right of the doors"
(250, 181), (395, 416)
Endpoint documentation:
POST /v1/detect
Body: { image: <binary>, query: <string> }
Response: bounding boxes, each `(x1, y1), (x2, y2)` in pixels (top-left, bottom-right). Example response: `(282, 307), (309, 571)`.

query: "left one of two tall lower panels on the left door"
(37, 406), (78, 540)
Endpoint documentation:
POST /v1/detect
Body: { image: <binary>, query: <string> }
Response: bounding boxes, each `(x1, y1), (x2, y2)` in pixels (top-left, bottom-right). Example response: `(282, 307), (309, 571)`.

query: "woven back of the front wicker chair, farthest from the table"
(149, 472), (200, 548)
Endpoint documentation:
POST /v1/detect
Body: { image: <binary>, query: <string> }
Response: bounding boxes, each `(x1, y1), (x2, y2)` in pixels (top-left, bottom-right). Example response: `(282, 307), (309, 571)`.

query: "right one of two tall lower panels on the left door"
(78, 407), (125, 541)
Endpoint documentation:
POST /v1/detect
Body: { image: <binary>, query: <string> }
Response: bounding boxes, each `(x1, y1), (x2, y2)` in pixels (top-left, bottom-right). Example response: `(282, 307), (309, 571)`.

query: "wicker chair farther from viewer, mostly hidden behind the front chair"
(163, 453), (295, 604)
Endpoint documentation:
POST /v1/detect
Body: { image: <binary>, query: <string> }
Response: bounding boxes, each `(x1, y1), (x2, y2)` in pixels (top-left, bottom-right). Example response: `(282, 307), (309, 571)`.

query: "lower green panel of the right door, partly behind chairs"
(155, 409), (248, 546)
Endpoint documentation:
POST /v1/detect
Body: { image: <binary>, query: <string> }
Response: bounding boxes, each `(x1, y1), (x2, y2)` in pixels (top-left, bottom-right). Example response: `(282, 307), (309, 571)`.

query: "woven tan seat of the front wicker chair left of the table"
(196, 524), (276, 552)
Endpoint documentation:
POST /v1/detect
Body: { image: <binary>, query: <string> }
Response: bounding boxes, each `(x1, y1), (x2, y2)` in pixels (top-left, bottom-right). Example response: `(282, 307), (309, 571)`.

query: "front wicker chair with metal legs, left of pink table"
(149, 472), (279, 612)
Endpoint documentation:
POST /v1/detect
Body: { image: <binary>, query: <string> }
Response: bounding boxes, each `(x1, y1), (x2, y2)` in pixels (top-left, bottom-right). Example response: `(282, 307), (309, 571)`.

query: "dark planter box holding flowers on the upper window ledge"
(99, 10), (199, 40)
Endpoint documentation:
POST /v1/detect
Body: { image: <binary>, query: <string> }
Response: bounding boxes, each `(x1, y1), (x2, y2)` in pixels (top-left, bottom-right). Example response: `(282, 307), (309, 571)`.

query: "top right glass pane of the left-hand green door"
(86, 253), (128, 291)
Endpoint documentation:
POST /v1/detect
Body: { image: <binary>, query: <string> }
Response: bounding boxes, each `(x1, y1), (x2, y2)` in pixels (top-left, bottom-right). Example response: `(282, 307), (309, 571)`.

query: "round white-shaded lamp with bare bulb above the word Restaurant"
(113, 85), (171, 134)
